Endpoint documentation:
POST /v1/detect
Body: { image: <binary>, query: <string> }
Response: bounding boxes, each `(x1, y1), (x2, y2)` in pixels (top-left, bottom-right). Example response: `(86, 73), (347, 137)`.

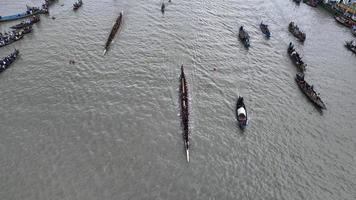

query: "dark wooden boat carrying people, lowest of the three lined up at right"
(295, 73), (326, 109)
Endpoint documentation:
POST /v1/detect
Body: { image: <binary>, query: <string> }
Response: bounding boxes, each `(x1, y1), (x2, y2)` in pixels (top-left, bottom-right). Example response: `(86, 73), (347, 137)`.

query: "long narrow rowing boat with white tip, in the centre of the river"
(179, 65), (189, 162)
